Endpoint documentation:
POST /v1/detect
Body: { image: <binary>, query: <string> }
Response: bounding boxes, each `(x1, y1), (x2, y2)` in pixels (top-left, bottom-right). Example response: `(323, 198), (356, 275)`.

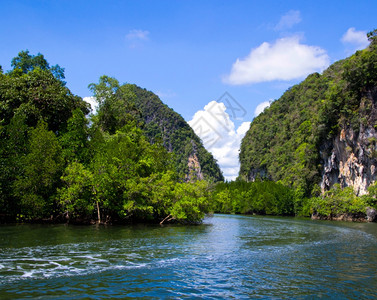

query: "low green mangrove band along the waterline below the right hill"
(211, 180), (377, 220)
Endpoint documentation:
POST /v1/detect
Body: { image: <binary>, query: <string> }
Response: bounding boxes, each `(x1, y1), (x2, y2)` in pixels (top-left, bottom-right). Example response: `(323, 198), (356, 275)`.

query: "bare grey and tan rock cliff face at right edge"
(320, 88), (377, 195)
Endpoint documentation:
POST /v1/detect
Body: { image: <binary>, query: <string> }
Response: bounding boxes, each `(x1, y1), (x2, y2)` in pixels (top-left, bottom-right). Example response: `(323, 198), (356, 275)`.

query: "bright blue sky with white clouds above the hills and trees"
(0, 0), (377, 179)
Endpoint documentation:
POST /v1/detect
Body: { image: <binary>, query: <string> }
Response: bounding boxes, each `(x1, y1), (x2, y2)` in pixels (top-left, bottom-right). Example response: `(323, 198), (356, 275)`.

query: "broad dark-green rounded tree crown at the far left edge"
(0, 51), (89, 134)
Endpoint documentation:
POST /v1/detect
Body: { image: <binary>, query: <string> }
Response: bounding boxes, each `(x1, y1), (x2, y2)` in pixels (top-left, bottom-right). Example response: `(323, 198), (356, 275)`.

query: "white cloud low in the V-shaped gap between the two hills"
(188, 101), (250, 180)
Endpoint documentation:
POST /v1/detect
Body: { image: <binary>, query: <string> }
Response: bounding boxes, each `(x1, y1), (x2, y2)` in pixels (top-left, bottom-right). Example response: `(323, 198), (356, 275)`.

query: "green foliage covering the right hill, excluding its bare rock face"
(239, 31), (377, 216)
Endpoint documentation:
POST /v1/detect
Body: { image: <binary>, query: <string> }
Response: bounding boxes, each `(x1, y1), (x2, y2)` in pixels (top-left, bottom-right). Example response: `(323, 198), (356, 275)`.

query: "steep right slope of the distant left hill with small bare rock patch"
(130, 85), (224, 181)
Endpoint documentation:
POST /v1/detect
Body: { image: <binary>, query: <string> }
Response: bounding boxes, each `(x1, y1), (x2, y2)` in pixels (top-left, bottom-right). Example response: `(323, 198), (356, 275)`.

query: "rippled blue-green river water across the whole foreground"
(0, 215), (377, 299)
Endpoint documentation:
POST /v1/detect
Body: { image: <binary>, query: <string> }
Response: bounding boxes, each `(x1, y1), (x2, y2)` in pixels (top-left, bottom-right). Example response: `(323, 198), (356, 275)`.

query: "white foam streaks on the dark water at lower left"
(0, 242), (157, 284)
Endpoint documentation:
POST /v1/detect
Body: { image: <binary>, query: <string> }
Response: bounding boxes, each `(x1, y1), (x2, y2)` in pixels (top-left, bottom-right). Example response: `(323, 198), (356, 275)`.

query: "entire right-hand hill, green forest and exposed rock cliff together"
(239, 30), (377, 218)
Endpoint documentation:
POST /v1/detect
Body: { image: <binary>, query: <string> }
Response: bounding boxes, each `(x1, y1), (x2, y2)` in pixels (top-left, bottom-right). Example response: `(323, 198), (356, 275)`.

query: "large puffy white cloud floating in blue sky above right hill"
(224, 36), (329, 85)
